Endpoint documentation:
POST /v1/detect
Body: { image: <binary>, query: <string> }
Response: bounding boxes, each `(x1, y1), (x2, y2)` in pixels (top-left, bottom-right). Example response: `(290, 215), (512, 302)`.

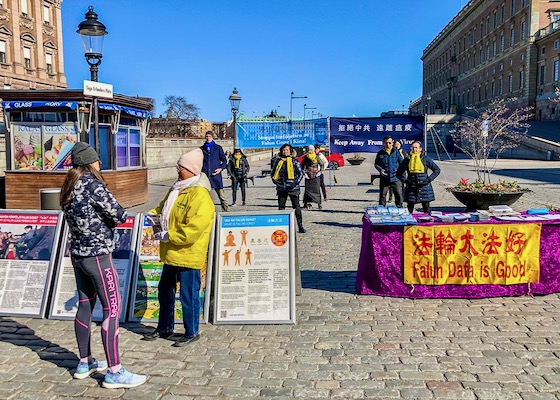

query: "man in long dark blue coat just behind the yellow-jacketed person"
(200, 131), (228, 211)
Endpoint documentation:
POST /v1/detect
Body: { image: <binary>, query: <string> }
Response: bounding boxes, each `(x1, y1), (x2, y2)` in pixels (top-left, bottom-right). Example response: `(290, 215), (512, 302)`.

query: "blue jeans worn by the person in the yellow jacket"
(157, 264), (200, 337)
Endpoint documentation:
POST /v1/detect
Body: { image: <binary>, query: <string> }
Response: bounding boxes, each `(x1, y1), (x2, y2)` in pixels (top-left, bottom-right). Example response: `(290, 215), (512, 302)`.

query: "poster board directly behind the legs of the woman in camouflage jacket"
(49, 215), (140, 322)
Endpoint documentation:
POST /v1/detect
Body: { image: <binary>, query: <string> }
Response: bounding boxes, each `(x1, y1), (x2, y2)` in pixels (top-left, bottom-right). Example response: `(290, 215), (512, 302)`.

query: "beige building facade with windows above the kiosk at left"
(0, 0), (68, 89)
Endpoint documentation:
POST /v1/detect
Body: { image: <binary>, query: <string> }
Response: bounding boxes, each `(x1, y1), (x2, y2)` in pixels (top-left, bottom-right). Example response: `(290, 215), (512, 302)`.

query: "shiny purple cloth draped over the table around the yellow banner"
(356, 217), (560, 298)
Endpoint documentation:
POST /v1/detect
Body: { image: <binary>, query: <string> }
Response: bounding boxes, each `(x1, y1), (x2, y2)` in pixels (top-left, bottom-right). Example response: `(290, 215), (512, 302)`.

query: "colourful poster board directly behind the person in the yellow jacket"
(128, 215), (214, 323)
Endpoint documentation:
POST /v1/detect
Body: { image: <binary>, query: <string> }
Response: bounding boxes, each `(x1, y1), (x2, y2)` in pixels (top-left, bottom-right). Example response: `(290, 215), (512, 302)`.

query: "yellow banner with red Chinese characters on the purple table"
(403, 223), (541, 285)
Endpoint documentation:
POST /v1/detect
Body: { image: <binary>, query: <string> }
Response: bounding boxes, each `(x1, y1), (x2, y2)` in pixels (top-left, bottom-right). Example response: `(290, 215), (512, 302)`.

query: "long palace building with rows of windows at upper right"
(421, 0), (560, 120)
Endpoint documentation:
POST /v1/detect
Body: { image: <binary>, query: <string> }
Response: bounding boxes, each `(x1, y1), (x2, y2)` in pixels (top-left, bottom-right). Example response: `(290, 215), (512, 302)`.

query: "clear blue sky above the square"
(62, 0), (466, 122)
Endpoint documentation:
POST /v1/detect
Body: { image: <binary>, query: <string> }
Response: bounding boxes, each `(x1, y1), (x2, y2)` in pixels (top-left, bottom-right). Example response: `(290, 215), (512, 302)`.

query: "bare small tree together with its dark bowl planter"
(447, 98), (532, 211)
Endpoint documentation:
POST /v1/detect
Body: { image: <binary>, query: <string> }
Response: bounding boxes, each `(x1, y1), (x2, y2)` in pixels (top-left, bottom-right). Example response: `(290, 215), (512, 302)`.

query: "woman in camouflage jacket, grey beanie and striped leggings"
(60, 142), (146, 389)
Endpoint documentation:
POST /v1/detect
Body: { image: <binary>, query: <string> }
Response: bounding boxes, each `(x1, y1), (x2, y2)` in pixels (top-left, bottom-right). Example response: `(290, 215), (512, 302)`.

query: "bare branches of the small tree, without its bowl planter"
(451, 98), (533, 184)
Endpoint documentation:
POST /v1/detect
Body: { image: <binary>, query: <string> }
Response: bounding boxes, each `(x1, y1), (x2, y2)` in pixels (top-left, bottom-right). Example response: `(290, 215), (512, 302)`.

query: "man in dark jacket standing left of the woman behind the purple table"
(374, 136), (403, 207)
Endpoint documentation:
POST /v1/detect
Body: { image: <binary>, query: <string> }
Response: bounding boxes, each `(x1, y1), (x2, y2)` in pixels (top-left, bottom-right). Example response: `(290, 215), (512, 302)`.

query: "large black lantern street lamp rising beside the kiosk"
(76, 6), (108, 154)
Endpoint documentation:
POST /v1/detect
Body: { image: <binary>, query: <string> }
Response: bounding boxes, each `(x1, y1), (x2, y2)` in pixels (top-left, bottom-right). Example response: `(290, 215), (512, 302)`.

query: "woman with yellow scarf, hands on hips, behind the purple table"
(397, 142), (440, 213)
